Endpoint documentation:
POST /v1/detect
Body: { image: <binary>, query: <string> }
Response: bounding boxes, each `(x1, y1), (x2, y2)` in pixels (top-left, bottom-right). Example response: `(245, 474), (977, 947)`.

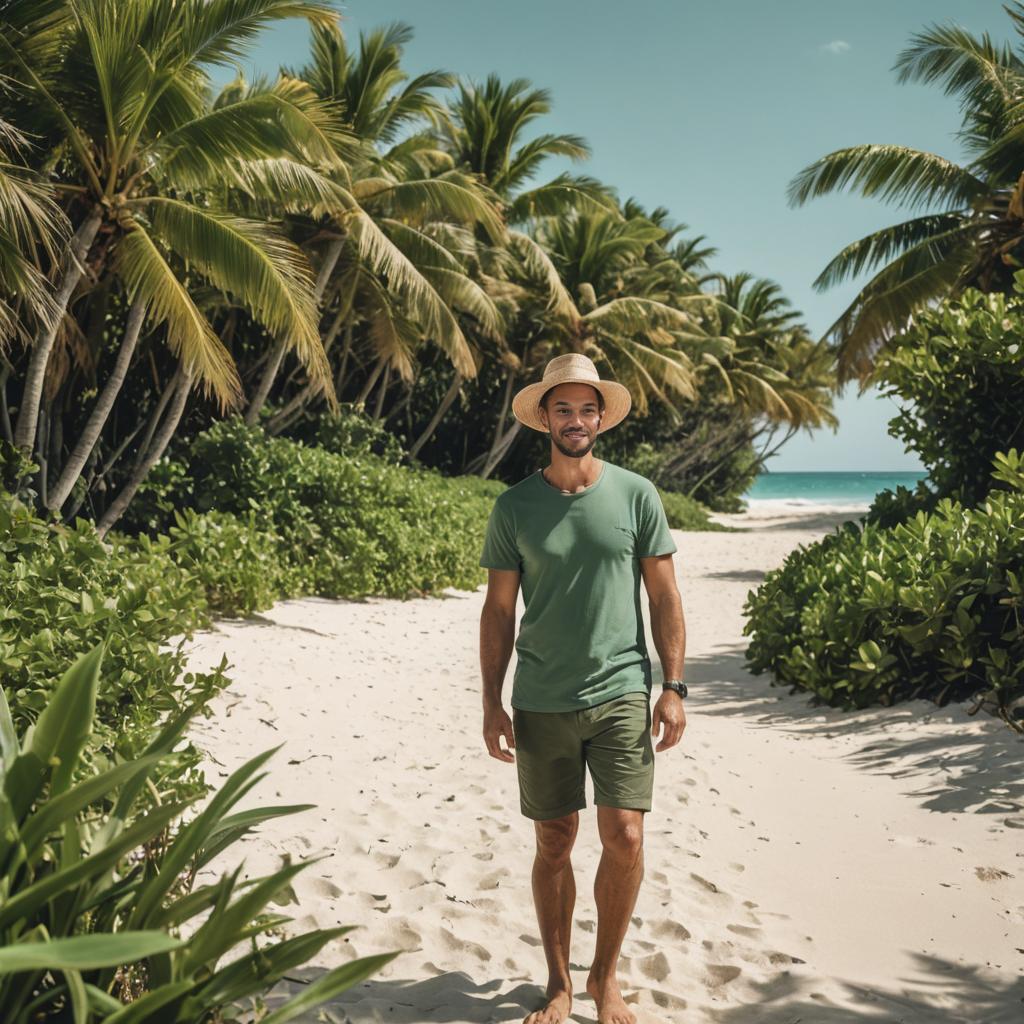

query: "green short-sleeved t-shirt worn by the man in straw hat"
(480, 462), (677, 712)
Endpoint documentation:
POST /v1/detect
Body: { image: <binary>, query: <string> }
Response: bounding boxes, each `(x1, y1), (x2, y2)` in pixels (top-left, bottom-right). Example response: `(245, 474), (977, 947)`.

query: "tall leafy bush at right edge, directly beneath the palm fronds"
(873, 278), (1024, 505)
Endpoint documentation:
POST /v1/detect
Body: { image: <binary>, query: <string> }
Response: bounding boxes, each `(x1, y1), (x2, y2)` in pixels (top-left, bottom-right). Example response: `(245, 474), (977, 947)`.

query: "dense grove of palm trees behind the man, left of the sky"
(0, 0), (831, 536)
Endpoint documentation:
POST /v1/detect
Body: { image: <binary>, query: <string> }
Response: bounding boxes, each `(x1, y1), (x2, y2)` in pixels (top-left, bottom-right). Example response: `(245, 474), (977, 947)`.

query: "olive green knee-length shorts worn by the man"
(512, 693), (654, 821)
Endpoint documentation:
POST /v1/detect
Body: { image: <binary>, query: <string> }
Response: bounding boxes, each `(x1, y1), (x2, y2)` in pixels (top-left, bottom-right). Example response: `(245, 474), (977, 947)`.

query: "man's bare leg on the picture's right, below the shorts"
(587, 806), (644, 1024)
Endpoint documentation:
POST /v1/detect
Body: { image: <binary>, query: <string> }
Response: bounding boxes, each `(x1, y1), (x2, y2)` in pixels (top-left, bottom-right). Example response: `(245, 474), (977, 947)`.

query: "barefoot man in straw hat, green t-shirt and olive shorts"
(480, 353), (686, 1024)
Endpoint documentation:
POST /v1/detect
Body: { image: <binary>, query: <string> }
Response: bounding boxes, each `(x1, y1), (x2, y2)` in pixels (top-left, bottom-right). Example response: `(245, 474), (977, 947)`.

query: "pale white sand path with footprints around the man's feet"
(180, 506), (1024, 1024)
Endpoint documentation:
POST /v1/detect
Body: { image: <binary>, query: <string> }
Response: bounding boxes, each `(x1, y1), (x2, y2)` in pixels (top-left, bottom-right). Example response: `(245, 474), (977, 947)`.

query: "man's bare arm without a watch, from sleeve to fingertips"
(480, 569), (519, 762)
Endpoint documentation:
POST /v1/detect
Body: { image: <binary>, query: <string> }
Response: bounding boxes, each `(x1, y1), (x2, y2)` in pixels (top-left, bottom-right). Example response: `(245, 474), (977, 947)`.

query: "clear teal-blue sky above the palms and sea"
(216, 0), (1019, 471)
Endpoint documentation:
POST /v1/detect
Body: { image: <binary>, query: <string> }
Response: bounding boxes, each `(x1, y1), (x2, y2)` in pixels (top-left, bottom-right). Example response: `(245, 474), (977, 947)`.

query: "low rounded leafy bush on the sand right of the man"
(743, 450), (1024, 731)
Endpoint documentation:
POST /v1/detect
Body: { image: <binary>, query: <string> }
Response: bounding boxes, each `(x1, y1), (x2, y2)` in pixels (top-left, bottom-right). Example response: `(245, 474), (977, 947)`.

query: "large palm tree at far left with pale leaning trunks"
(0, 0), (345, 520)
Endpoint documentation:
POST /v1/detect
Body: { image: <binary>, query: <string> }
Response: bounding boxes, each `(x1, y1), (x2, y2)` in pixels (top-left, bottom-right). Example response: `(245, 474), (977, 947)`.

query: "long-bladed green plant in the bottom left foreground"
(0, 646), (396, 1024)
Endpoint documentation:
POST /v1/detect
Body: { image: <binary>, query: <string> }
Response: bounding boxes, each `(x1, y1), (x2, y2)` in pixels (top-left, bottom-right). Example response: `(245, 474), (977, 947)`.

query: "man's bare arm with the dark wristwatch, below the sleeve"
(640, 555), (686, 751)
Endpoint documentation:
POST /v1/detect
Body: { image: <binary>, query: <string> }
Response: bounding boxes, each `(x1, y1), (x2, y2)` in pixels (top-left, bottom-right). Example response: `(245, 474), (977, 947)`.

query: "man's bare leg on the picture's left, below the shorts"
(525, 811), (580, 1024)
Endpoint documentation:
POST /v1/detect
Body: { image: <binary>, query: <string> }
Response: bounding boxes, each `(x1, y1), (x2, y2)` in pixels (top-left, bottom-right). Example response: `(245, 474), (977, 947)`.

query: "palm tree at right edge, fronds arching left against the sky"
(788, 3), (1024, 390)
